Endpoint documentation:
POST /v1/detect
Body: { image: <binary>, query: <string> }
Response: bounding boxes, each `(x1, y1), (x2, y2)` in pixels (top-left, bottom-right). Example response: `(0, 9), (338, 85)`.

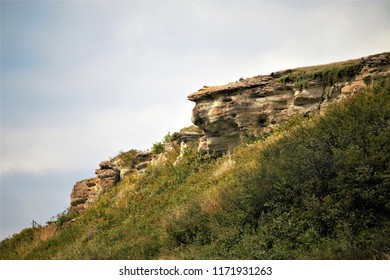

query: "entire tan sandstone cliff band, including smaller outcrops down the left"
(70, 53), (390, 211)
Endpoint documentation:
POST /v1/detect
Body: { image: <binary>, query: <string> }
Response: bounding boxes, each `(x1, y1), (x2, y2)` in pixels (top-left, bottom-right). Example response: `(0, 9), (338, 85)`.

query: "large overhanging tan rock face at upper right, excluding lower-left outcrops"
(188, 53), (390, 156)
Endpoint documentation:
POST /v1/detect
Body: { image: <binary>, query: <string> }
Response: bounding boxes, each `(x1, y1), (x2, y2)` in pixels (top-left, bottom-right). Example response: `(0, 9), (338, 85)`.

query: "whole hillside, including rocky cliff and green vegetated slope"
(0, 53), (390, 259)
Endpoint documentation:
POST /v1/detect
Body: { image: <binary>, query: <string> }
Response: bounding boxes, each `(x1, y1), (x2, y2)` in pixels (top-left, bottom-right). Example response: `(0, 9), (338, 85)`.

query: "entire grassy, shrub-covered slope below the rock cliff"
(0, 80), (390, 259)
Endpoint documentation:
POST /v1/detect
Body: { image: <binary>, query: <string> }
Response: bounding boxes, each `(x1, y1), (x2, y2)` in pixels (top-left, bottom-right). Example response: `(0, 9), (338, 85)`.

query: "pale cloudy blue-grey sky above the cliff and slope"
(0, 0), (390, 240)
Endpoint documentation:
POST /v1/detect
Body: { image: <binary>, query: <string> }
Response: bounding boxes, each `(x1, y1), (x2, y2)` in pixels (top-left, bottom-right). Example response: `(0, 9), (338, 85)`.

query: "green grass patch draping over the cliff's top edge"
(278, 60), (362, 88)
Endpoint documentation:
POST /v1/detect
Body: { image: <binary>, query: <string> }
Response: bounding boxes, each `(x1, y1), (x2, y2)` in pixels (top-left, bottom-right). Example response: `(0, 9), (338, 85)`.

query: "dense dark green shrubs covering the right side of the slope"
(222, 78), (390, 258)
